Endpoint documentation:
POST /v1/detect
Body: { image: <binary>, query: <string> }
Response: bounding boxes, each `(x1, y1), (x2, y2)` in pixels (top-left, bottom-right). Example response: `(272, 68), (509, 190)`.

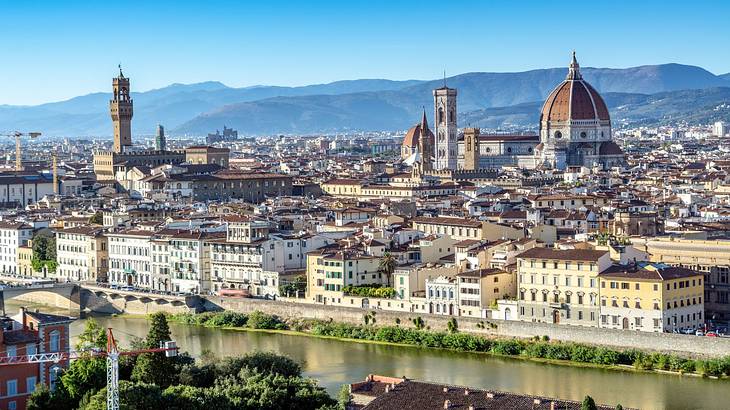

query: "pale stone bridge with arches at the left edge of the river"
(0, 275), (202, 314)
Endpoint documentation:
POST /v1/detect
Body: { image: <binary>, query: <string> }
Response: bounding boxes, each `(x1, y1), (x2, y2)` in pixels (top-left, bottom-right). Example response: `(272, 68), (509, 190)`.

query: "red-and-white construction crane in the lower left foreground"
(0, 328), (178, 410)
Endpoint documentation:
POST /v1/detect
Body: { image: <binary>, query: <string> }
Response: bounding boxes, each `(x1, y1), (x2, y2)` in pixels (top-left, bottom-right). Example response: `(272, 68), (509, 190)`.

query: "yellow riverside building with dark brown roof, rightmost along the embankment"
(599, 263), (705, 332)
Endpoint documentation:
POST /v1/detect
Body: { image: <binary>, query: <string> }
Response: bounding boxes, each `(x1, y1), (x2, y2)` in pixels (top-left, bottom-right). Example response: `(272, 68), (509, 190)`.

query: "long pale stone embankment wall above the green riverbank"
(203, 297), (730, 357)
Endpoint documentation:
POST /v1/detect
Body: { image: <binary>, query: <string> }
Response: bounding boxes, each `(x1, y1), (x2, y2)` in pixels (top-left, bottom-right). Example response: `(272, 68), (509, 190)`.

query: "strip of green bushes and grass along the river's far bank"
(170, 312), (730, 378)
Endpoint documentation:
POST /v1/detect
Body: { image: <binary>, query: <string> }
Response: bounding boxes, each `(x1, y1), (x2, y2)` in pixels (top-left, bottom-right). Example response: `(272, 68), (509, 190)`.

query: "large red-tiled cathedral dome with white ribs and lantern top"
(540, 52), (611, 122)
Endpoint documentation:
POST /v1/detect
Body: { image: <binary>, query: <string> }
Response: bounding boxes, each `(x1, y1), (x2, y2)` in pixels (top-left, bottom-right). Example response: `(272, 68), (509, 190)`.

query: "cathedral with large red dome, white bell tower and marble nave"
(402, 53), (624, 171)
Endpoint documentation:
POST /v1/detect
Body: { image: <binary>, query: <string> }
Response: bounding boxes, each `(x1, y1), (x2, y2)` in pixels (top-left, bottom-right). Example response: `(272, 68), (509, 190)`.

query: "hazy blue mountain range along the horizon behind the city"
(0, 64), (730, 136)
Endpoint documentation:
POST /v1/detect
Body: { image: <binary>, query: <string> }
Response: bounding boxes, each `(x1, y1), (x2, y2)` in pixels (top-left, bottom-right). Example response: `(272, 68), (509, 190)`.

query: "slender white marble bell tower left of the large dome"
(433, 85), (457, 170)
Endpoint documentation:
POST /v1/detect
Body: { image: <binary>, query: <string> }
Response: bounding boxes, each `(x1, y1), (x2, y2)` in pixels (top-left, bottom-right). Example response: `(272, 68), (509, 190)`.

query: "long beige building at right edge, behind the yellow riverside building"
(646, 238), (730, 323)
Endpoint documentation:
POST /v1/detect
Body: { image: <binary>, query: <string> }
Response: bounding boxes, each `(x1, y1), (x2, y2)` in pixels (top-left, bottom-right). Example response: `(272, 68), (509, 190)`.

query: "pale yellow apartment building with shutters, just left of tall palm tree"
(307, 249), (388, 304)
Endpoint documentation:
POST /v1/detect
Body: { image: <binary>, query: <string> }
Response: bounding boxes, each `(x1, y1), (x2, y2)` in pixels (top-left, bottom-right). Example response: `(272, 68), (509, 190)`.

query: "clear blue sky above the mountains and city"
(0, 0), (730, 104)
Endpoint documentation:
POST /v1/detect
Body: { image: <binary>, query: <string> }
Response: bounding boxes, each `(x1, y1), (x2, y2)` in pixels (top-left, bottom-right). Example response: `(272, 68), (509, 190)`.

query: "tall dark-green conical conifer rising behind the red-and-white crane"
(132, 312), (178, 388)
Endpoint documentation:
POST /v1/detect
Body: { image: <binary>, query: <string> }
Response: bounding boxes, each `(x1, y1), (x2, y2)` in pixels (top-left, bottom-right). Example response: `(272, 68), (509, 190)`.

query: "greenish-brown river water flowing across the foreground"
(8, 303), (730, 409)
